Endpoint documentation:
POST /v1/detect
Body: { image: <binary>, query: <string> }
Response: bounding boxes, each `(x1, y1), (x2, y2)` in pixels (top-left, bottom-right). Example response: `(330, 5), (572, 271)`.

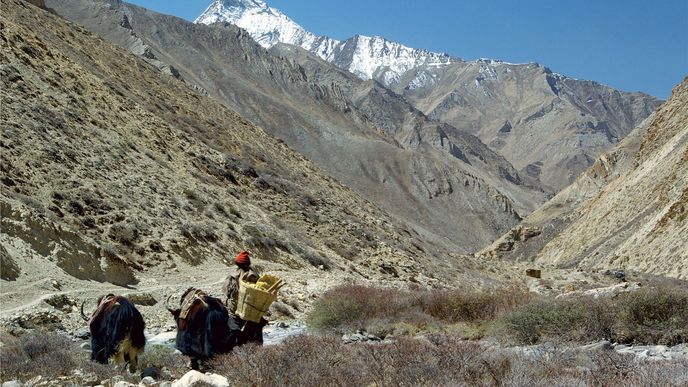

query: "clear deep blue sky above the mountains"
(129, 0), (688, 98)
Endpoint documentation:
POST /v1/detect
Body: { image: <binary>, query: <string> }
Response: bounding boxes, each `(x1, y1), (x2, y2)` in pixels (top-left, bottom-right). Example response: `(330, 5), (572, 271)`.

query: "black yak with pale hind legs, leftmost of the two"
(81, 294), (146, 373)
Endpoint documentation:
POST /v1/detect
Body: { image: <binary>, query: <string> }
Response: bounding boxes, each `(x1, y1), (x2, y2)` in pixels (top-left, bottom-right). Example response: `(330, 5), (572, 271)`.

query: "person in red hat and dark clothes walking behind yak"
(222, 251), (268, 346)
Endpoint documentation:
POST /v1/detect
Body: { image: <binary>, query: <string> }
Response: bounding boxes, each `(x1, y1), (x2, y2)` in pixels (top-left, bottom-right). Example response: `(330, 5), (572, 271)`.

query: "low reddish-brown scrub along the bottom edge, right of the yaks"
(208, 335), (688, 386)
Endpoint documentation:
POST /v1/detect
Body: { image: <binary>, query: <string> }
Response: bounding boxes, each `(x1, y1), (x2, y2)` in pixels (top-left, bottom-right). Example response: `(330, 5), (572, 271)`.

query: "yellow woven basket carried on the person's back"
(236, 274), (285, 323)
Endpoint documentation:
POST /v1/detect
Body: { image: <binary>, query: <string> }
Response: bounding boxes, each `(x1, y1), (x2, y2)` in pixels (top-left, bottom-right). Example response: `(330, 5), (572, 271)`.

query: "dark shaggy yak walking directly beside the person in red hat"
(167, 287), (233, 370)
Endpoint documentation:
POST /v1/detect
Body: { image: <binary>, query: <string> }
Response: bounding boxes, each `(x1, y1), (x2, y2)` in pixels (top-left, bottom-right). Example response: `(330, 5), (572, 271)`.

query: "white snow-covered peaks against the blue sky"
(196, 0), (452, 85)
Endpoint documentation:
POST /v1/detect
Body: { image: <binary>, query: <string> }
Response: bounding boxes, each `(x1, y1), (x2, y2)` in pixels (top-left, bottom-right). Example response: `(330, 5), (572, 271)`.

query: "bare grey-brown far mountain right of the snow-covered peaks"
(394, 59), (661, 192)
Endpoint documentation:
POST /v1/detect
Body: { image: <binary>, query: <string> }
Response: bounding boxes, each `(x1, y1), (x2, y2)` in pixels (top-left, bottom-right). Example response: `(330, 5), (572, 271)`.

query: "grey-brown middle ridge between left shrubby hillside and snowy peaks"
(47, 0), (545, 252)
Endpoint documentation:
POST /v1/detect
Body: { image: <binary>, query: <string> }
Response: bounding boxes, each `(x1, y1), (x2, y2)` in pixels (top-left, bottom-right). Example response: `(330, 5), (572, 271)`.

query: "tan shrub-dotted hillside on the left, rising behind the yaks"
(0, 0), (512, 314)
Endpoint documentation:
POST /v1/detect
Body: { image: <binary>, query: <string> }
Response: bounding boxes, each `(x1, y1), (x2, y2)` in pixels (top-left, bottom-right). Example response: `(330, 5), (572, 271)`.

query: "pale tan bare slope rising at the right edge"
(481, 79), (688, 278)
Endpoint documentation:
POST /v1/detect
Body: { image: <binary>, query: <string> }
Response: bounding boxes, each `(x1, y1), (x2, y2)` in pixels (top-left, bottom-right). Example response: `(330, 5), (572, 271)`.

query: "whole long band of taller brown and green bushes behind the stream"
(308, 285), (688, 345)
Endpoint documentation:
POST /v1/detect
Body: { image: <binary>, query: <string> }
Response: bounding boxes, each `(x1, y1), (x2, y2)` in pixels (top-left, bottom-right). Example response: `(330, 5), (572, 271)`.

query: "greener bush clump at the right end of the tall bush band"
(499, 287), (688, 345)
